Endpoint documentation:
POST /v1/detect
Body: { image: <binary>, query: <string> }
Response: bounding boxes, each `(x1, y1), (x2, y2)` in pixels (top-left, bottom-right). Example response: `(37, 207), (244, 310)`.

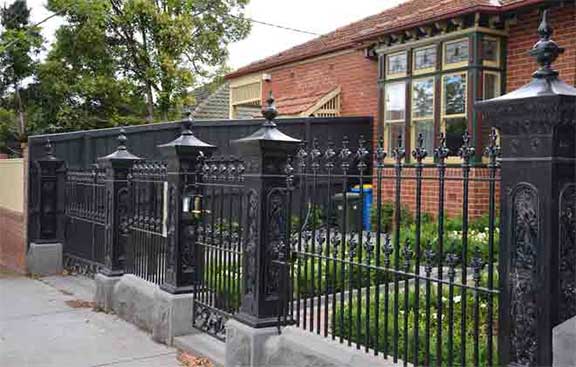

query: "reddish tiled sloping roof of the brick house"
(226, 0), (544, 79)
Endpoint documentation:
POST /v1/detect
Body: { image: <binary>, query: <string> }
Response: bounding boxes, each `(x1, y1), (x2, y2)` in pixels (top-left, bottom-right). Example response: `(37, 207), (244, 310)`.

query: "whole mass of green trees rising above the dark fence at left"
(0, 0), (249, 145)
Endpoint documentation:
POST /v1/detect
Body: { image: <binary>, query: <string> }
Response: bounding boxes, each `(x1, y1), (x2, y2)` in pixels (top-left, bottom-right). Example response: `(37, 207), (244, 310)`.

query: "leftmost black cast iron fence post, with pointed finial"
(32, 139), (66, 243)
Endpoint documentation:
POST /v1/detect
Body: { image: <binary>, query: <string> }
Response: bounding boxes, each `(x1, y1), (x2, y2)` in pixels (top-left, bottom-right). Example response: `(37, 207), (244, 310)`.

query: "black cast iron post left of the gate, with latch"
(158, 114), (216, 294)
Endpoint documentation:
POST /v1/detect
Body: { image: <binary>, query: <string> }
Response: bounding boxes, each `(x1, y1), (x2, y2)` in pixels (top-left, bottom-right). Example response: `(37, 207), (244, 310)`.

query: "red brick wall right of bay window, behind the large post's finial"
(506, 4), (576, 92)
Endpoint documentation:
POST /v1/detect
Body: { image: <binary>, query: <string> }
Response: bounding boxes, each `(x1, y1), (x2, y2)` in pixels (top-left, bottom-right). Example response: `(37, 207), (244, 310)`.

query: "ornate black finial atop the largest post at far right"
(530, 10), (564, 79)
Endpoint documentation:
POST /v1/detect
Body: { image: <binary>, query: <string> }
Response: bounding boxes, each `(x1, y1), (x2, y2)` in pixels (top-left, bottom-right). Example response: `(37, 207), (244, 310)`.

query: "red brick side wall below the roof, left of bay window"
(262, 50), (378, 117)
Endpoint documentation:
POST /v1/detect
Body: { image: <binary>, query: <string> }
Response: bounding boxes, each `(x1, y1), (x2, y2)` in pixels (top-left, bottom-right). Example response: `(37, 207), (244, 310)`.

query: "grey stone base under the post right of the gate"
(225, 320), (278, 367)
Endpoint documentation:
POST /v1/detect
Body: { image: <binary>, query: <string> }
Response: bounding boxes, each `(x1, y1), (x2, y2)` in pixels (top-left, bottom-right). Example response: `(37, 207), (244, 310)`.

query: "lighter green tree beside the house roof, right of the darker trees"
(49, 0), (249, 119)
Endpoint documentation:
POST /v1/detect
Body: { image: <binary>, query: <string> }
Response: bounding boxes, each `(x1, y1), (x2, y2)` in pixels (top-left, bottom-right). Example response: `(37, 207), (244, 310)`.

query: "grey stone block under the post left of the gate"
(152, 288), (194, 345)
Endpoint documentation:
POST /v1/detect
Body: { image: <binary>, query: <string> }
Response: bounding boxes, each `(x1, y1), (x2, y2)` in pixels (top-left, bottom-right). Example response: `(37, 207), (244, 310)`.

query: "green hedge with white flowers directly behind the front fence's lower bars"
(333, 282), (498, 366)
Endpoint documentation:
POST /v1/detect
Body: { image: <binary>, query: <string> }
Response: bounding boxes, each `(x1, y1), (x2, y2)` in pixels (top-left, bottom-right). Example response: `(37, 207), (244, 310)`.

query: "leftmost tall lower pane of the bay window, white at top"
(384, 82), (406, 153)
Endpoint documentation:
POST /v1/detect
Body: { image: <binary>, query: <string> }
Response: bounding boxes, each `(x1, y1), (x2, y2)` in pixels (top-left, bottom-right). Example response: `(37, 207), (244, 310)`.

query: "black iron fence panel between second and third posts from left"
(125, 161), (170, 284)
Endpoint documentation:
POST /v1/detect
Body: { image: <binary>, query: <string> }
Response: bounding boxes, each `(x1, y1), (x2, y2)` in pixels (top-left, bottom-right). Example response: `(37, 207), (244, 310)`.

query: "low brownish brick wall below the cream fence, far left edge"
(0, 207), (26, 273)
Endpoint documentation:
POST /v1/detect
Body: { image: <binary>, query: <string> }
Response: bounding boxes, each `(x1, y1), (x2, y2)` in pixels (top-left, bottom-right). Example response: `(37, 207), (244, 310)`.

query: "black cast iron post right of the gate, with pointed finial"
(233, 94), (300, 328)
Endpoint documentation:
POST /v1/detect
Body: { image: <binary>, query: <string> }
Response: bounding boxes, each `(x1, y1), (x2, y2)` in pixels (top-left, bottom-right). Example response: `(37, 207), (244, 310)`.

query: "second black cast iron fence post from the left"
(98, 129), (140, 277)
